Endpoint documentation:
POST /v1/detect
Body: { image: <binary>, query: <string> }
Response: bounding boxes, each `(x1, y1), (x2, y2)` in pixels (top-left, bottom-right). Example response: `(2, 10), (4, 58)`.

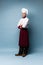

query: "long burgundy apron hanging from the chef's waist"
(19, 28), (29, 47)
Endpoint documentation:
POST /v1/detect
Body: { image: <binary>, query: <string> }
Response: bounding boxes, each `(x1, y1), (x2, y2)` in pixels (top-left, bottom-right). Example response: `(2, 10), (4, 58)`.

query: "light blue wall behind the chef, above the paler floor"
(0, 0), (43, 49)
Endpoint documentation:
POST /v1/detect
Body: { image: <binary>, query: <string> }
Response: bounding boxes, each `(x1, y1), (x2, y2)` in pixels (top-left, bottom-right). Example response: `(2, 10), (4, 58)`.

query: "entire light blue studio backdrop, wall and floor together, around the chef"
(0, 0), (43, 65)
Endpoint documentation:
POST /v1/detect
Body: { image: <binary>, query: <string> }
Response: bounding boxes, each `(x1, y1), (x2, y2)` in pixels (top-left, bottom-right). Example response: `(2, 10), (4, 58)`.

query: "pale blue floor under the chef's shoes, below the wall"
(0, 49), (43, 65)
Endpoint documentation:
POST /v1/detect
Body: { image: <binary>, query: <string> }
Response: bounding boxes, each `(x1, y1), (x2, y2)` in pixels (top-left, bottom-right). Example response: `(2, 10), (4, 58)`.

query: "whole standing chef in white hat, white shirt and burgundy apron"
(15, 8), (29, 57)
